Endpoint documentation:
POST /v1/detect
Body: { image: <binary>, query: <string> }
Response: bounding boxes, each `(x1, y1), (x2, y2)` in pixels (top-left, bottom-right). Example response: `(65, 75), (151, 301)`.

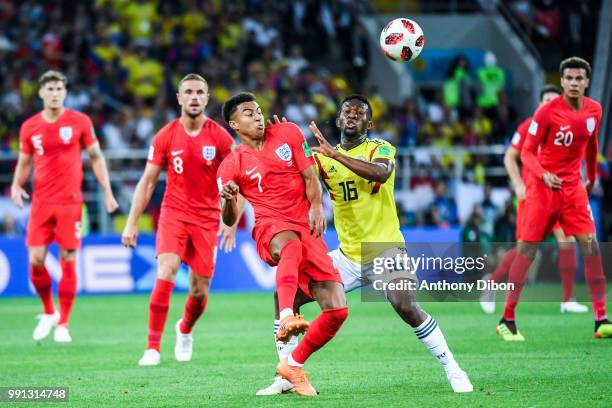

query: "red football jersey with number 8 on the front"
(148, 118), (234, 228)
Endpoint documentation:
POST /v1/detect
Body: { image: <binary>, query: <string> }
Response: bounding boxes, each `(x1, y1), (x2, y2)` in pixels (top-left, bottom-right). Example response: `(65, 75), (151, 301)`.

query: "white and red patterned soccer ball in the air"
(380, 18), (425, 62)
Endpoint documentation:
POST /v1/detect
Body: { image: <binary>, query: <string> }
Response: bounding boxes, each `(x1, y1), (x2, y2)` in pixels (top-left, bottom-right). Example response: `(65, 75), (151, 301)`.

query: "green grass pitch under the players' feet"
(0, 293), (612, 408)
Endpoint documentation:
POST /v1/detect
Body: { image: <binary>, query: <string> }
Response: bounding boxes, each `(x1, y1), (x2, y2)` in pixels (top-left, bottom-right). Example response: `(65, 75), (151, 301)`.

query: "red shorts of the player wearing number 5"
(26, 201), (82, 250)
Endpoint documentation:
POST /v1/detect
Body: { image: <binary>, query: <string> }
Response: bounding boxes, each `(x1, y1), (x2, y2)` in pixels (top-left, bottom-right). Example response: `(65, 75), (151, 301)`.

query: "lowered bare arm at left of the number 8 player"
(121, 163), (161, 248)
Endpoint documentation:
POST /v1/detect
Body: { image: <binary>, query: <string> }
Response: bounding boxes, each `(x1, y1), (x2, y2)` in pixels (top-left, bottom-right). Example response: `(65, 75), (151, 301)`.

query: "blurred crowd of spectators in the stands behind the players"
(0, 0), (608, 239)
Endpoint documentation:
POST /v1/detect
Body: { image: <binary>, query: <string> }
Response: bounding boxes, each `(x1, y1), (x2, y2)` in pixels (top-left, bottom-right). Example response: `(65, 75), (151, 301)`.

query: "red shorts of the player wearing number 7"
(253, 222), (342, 299)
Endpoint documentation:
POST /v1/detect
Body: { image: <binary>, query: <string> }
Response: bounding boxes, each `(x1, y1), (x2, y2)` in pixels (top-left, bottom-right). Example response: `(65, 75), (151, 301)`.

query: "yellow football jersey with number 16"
(315, 139), (404, 264)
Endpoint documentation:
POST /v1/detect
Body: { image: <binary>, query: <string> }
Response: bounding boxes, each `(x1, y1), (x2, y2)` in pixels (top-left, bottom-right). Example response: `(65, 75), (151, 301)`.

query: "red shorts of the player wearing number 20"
(521, 180), (595, 242)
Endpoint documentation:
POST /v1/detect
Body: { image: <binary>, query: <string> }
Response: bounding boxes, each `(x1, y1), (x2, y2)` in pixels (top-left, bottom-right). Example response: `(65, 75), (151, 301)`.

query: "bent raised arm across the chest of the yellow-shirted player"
(310, 122), (393, 183)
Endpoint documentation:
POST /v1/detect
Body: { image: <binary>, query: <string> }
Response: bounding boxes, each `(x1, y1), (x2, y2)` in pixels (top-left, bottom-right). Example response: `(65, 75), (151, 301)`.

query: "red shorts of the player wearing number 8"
(155, 216), (218, 278)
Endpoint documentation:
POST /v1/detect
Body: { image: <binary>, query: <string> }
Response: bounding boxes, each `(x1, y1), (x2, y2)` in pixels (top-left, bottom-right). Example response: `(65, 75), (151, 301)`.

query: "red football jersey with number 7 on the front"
(217, 123), (314, 228)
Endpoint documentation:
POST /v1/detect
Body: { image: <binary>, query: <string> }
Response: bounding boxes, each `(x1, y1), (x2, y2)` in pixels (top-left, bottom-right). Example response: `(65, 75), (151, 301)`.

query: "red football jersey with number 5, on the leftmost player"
(19, 109), (98, 204)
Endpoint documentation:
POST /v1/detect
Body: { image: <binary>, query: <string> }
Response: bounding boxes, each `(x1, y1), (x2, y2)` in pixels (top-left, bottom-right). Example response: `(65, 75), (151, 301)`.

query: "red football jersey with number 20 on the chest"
(521, 95), (601, 185)
